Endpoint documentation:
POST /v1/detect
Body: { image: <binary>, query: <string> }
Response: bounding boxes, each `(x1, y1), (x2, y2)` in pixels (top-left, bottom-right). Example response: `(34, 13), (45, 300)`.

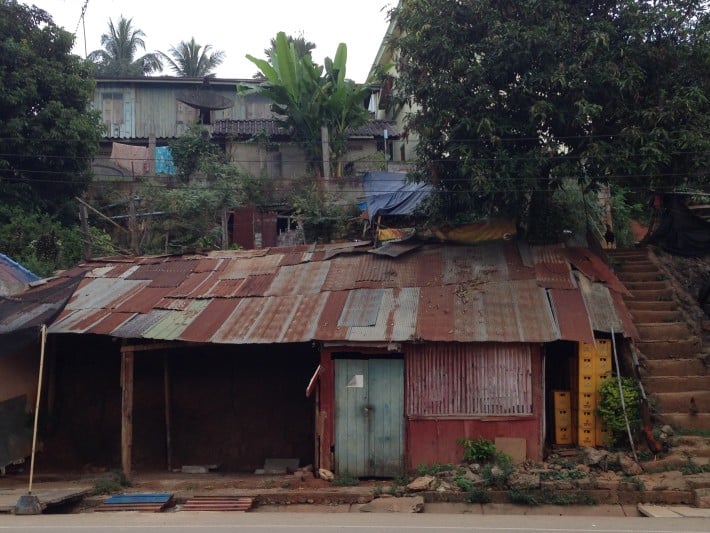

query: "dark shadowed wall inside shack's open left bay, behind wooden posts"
(37, 335), (317, 472)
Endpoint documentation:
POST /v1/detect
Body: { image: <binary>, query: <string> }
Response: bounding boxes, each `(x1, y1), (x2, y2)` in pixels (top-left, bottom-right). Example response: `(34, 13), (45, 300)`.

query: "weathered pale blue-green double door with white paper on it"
(335, 358), (404, 477)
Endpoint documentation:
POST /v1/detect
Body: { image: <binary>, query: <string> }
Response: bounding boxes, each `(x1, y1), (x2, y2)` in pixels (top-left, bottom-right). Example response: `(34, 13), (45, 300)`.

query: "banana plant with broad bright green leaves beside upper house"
(243, 32), (369, 175)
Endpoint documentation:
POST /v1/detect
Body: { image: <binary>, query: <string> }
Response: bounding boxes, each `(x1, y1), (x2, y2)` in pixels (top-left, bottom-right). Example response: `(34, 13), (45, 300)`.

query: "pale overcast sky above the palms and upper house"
(27, 0), (396, 82)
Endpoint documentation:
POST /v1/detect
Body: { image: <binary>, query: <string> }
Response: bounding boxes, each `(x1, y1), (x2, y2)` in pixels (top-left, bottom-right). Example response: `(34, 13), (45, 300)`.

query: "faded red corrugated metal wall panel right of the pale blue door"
(405, 343), (532, 417)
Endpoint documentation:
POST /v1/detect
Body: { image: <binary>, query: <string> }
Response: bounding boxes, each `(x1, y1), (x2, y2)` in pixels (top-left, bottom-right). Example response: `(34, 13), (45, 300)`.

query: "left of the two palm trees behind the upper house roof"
(89, 15), (163, 76)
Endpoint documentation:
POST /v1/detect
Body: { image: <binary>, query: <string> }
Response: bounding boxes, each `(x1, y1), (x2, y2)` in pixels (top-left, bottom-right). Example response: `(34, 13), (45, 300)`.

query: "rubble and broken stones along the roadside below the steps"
(394, 437), (710, 507)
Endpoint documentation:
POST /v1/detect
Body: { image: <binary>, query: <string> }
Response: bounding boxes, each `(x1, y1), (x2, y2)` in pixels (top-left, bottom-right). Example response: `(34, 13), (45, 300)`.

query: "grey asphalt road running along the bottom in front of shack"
(0, 511), (710, 533)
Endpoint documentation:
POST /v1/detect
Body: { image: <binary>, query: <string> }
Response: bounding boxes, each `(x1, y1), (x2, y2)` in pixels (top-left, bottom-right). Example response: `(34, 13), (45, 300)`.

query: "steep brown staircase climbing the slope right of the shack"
(606, 248), (710, 430)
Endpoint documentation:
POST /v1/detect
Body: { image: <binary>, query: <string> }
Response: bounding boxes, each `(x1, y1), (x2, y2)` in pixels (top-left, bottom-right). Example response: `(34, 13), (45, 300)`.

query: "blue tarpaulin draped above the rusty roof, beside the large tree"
(363, 172), (431, 221)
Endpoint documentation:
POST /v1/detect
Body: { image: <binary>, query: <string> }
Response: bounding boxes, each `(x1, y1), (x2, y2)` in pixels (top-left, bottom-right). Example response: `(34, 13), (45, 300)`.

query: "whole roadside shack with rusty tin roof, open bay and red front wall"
(0, 241), (635, 477)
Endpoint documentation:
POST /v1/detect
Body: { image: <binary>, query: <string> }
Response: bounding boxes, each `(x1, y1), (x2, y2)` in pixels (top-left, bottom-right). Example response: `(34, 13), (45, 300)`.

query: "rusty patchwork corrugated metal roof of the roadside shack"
(30, 242), (634, 344)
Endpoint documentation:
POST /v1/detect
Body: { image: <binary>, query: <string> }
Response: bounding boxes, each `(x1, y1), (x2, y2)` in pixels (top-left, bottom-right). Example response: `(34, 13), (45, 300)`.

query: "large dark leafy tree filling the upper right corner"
(390, 0), (710, 240)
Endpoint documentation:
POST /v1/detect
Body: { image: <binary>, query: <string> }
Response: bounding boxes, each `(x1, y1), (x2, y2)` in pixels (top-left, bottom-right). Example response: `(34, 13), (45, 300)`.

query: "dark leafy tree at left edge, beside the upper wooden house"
(0, 0), (102, 218)
